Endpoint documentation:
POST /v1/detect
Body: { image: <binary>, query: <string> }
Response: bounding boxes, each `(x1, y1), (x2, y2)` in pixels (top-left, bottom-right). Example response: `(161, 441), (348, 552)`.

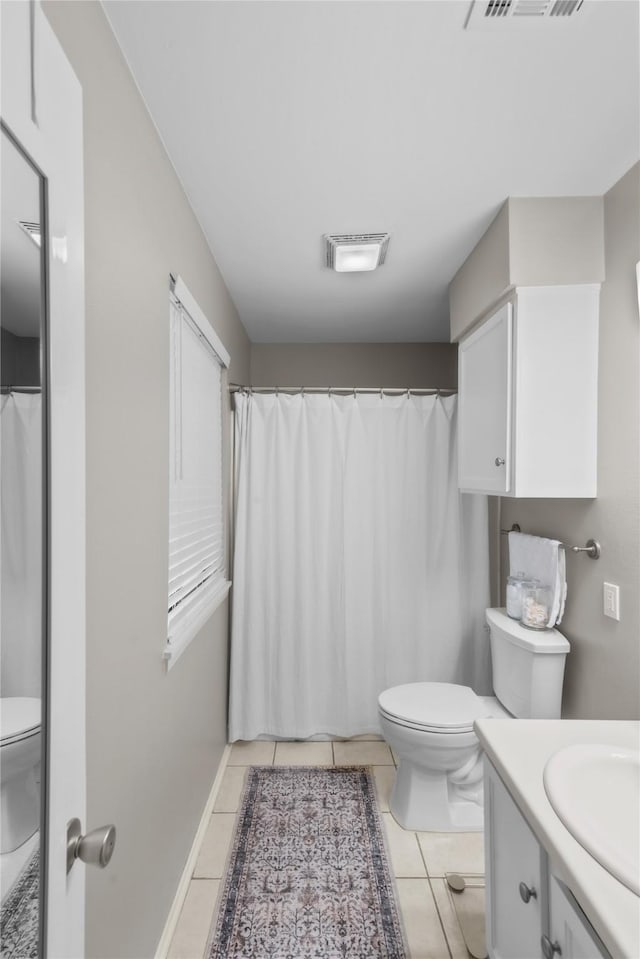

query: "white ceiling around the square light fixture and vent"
(104, 0), (640, 342)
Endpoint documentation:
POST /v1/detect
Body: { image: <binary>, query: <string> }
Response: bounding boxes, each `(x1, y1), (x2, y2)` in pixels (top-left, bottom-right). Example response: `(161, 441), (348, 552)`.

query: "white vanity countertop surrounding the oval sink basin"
(475, 719), (640, 959)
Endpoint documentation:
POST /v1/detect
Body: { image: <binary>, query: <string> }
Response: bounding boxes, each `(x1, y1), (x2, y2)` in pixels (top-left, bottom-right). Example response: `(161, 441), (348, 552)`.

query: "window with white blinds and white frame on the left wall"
(164, 277), (231, 668)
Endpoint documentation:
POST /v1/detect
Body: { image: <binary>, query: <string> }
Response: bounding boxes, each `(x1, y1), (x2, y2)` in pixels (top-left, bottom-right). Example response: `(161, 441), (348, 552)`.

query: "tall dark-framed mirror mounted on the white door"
(0, 128), (47, 959)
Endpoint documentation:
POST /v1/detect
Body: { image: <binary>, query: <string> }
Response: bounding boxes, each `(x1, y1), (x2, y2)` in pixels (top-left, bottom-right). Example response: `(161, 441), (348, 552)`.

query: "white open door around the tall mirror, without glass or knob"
(0, 3), (85, 959)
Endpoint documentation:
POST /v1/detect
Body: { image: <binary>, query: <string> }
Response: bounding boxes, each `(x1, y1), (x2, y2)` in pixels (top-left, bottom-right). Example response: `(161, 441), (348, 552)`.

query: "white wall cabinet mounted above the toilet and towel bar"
(458, 284), (600, 498)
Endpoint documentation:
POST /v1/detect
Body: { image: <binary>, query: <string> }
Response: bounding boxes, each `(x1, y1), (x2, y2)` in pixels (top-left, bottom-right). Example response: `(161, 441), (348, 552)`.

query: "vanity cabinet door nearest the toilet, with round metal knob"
(485, 763), (546, 959)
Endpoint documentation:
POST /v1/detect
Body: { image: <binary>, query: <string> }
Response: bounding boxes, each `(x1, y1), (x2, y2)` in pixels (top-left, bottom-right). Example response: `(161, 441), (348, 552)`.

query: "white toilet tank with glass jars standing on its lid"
(486, 609), (570, 719)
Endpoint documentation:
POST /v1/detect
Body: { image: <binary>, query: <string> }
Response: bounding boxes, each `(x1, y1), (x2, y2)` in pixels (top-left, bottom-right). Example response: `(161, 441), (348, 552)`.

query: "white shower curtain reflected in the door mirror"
(0, 393), (42, 697)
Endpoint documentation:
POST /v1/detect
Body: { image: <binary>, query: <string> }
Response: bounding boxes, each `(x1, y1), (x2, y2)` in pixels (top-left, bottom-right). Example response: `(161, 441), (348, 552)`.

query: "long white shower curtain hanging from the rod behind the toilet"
(229, 393), (490, 741)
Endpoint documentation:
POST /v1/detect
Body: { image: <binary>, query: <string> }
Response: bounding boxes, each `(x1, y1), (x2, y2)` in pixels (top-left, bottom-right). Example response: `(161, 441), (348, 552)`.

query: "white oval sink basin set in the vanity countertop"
(544, 744), (640, 896)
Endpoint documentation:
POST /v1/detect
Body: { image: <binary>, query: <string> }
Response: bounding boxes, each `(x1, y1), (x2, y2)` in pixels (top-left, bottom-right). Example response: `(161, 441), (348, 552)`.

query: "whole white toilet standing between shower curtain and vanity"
(378, 609), (569, 832)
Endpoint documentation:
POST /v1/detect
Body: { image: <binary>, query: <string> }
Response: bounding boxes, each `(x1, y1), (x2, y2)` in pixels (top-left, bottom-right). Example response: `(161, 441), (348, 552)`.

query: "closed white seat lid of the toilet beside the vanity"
(378, 683), (491, 735)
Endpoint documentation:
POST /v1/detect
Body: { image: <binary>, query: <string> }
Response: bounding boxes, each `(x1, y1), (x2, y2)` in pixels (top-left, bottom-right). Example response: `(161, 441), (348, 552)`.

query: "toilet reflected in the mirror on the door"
(0, 696), (41, 853)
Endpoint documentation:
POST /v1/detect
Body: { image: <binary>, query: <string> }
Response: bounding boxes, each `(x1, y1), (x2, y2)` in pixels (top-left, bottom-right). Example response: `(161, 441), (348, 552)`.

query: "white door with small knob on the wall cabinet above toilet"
(458, 303), (512, 493)
